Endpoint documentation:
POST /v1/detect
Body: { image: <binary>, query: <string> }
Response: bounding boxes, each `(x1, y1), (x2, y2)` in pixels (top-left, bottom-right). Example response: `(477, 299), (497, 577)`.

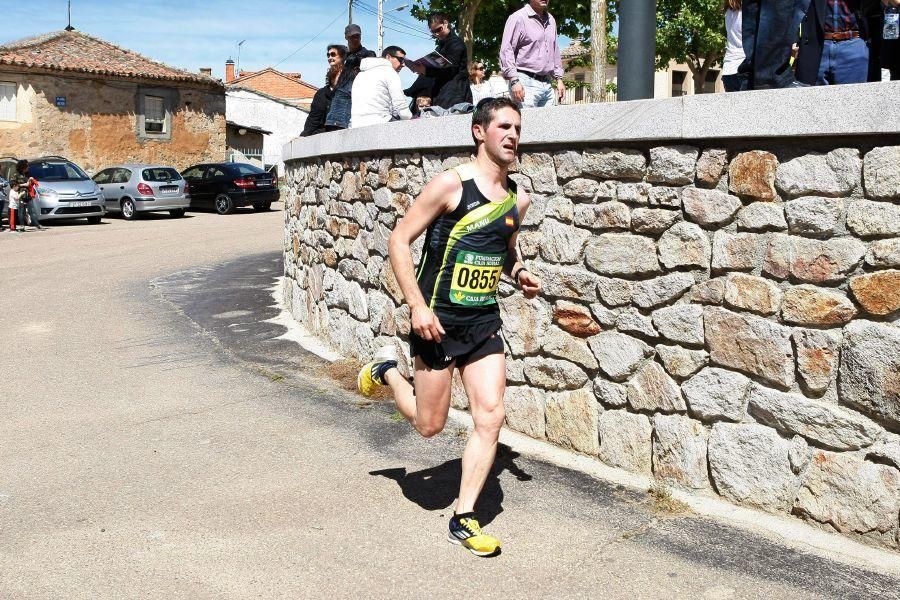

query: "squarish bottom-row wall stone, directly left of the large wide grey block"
(653, 415), (710, 489)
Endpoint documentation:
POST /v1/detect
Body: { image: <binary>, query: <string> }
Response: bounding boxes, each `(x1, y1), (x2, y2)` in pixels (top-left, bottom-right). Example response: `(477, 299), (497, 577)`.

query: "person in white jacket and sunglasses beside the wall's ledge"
(350, 46), (412, 128)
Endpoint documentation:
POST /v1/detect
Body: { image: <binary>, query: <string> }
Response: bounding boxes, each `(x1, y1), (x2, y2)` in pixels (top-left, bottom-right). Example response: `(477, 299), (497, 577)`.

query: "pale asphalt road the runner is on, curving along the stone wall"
(0, 212), (900, 600)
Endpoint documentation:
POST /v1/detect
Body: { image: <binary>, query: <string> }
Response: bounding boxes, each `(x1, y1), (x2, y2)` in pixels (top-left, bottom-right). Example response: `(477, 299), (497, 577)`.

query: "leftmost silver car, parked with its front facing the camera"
(0, 156), (106, 224)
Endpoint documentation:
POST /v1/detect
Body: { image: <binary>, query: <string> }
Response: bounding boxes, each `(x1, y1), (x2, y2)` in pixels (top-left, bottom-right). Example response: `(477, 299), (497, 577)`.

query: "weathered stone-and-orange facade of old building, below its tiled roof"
(0, 71), (225, 173)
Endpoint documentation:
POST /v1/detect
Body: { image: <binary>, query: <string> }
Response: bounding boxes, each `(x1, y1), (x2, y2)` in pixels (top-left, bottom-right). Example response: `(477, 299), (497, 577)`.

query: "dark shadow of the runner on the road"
(369, 444), (532, 526)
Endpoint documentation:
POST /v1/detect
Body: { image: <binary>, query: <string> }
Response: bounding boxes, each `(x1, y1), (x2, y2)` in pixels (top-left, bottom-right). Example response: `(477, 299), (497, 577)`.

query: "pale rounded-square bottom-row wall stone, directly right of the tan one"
(598, 410), (653, 475)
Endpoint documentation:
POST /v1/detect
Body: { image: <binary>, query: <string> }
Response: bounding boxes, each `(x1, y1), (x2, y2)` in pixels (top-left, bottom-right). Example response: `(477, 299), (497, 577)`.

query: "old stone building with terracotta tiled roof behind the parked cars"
(0, 31), (225, 171)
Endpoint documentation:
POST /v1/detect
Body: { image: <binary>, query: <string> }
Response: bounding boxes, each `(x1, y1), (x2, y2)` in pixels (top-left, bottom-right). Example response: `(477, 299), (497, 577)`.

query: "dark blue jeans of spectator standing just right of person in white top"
(738, 0), (809, 89)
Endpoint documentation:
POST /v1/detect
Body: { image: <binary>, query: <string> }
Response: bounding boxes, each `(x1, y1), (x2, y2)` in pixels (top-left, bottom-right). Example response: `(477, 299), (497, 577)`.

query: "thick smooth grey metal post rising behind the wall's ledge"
(618, 0), (656, 100)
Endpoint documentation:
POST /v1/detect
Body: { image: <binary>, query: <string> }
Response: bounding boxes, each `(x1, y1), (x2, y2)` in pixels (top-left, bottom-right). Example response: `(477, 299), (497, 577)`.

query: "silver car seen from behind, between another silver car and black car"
(94, 164), (191, 220)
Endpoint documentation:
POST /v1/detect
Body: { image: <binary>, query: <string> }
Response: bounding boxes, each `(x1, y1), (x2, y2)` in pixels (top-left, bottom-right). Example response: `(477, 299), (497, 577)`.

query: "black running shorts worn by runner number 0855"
(409, 319), (504, 370)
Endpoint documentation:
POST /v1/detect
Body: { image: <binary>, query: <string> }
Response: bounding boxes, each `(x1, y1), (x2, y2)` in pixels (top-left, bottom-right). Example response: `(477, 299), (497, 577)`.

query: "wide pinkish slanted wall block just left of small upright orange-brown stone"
(704, 306), (794, 389)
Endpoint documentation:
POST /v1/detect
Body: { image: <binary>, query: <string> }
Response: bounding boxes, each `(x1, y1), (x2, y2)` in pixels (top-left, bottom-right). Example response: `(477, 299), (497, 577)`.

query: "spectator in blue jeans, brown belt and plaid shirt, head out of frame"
(796, 0), (869, 85)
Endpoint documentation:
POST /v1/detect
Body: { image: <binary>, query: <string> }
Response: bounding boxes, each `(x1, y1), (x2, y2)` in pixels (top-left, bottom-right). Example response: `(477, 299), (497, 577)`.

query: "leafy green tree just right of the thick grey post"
(656, 0), (726, 93)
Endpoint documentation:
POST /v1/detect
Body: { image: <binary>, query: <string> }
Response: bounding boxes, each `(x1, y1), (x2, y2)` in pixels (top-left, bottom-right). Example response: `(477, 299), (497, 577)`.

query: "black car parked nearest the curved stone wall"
(181, 163), (279, 215)
